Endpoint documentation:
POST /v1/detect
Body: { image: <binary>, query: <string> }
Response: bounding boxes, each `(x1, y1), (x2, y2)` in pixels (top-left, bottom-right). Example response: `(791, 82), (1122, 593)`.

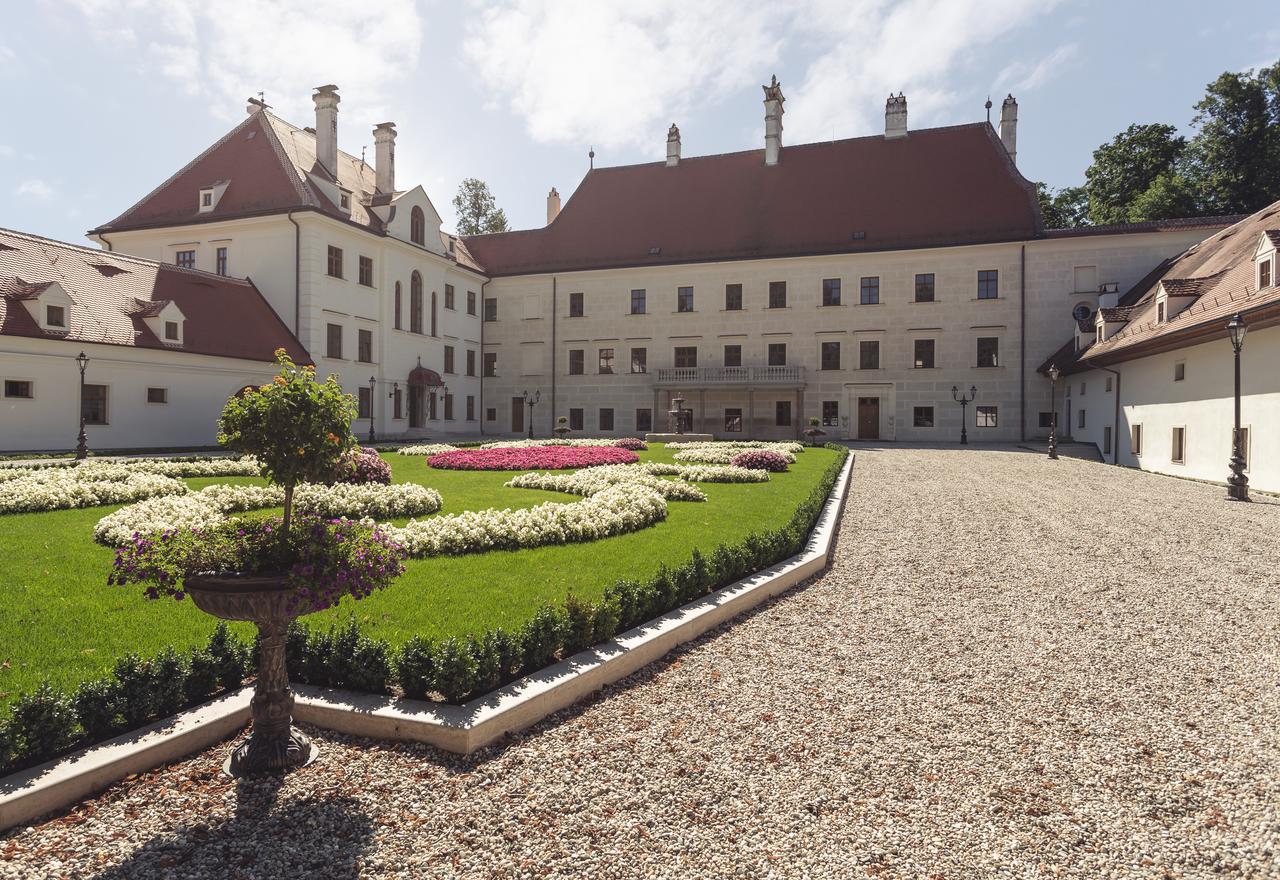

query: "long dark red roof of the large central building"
(465, 123), (1039, 275)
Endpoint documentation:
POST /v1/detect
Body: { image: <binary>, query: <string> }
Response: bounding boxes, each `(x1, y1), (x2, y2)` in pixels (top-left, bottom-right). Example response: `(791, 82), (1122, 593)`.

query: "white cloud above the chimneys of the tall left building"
(70, 0), (422, 127)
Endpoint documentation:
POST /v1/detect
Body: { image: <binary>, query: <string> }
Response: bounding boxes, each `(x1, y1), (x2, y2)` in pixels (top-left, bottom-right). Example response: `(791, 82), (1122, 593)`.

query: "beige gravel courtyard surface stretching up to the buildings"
(0, 448), (1280, 880)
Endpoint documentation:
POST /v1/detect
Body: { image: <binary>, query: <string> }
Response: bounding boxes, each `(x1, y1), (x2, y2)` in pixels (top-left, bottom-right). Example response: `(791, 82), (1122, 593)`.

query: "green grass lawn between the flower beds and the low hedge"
(0, 446), (836, 705)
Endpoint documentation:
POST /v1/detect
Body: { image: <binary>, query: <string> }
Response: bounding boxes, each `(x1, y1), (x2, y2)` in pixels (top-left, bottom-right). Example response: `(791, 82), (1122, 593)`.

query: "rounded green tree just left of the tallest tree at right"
(1084, 123), (1187, 224)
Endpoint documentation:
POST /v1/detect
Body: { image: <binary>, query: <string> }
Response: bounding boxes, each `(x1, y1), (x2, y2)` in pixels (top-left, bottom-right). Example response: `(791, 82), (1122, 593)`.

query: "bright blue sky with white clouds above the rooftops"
(0, 0), (1280, 243)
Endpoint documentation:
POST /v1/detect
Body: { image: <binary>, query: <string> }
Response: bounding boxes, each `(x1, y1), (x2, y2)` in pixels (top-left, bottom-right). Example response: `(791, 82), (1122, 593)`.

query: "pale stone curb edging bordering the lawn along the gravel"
(0, 452), (855, 833)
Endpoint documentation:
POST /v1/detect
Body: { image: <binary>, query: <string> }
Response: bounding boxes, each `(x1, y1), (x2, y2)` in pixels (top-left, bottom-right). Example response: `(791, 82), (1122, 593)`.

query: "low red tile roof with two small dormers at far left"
(0, 229), (311, 363)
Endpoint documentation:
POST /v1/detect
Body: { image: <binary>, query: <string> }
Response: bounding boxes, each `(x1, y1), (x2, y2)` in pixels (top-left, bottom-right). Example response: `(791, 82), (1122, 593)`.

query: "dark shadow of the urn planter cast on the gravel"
(97, 776), (374, 880)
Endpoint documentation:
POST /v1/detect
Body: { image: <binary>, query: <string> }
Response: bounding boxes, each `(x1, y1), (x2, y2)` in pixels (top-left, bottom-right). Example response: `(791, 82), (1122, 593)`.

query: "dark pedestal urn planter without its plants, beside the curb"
(183, 574), (319, 778)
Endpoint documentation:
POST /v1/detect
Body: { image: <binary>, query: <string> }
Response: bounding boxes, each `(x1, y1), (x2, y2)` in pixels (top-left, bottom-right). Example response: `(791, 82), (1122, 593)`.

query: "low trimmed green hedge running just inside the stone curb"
(0, 444), (849, 774)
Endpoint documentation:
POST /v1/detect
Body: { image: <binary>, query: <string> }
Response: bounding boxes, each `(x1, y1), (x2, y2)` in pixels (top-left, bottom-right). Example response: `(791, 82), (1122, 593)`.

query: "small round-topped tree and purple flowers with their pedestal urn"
(110, 350), (404, 776)
